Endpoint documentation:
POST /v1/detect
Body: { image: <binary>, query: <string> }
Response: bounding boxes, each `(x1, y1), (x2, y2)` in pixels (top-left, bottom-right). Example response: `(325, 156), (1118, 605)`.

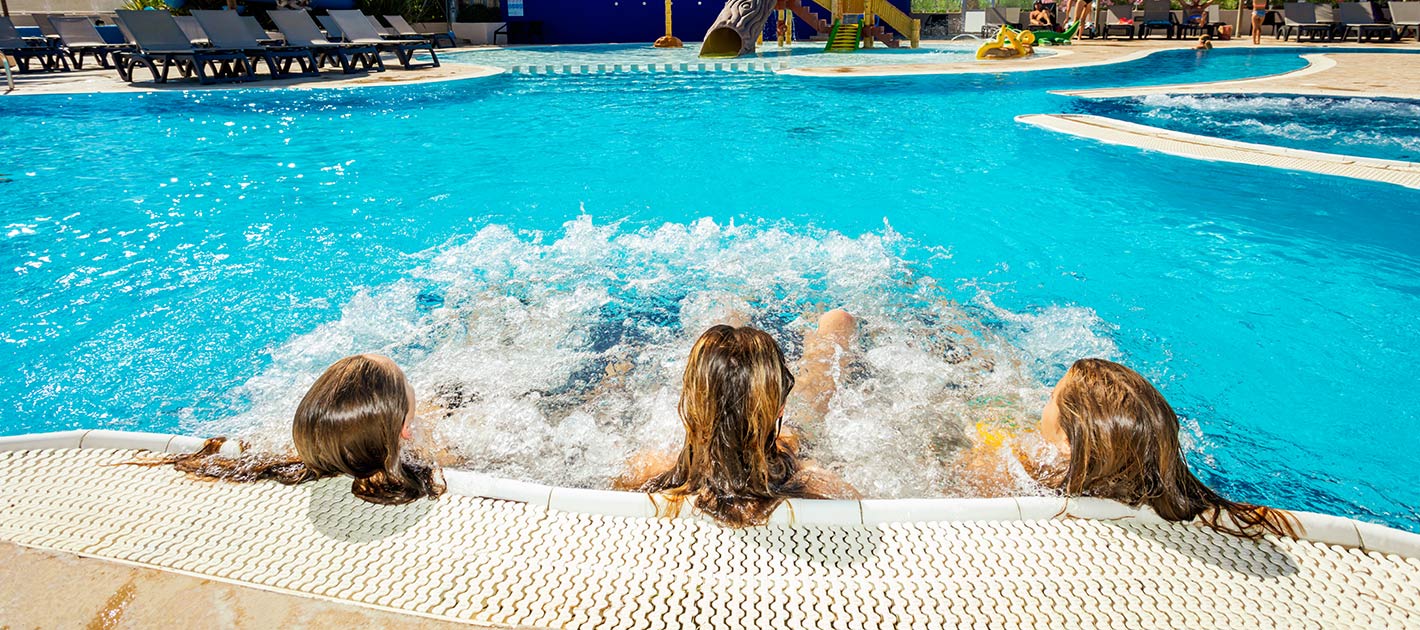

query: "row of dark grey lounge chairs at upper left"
(0, 10), (453, 84)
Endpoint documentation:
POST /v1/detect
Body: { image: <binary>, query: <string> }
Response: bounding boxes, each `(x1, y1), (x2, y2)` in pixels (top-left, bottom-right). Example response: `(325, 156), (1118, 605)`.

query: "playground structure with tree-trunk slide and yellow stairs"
(698, 0), (922, 57)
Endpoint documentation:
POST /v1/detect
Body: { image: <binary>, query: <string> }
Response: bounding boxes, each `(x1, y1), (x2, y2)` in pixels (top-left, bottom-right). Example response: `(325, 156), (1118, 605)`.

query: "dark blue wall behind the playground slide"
(503, 0), (910, 44)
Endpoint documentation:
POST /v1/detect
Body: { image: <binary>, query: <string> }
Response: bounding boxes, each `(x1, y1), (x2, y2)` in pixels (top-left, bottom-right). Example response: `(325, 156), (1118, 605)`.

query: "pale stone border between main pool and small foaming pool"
(1015, 114), (1420, 189)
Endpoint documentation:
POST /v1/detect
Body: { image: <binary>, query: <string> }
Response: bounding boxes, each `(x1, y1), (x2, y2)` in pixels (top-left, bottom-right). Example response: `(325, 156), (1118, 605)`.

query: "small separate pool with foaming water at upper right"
(1081, 94), (1420, 162)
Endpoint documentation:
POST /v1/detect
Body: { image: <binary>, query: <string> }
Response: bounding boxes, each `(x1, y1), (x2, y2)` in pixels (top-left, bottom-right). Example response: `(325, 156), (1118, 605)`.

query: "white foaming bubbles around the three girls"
(196, 216), (1115, 498)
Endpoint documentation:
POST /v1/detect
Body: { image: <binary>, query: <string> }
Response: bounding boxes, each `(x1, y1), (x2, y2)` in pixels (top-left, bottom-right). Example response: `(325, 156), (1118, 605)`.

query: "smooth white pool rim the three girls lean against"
(0, 430), (1420, 558)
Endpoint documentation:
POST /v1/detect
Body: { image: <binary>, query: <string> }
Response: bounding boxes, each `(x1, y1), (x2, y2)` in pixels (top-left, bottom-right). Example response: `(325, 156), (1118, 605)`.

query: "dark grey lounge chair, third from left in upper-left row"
(115, 10), (256, 85)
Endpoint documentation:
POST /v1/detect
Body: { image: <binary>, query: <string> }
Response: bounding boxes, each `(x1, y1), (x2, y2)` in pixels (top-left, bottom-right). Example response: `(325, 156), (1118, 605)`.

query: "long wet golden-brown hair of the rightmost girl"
(1048, 359), (1296, 539)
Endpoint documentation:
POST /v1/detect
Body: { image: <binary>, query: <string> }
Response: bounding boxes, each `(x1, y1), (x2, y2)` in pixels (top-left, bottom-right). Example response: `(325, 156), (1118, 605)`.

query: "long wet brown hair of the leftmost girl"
(158, 355), (444, 505)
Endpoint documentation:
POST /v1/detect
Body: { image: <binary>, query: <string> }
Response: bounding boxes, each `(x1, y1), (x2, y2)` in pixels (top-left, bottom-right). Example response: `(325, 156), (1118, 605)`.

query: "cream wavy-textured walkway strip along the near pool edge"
(0, 448), (1420, 629)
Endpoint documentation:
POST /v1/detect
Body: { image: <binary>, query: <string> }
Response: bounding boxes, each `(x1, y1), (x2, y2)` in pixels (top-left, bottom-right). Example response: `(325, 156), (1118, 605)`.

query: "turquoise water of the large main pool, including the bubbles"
(0, 50), (1420, 531)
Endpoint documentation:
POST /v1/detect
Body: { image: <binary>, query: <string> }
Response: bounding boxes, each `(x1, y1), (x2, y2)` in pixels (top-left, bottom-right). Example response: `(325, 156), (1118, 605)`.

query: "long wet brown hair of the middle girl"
(639, 325), (822, 528)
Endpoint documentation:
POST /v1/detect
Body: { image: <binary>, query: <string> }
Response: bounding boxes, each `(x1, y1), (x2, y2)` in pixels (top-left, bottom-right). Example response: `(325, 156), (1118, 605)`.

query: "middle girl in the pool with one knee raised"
(615, 311), (856, 526)
